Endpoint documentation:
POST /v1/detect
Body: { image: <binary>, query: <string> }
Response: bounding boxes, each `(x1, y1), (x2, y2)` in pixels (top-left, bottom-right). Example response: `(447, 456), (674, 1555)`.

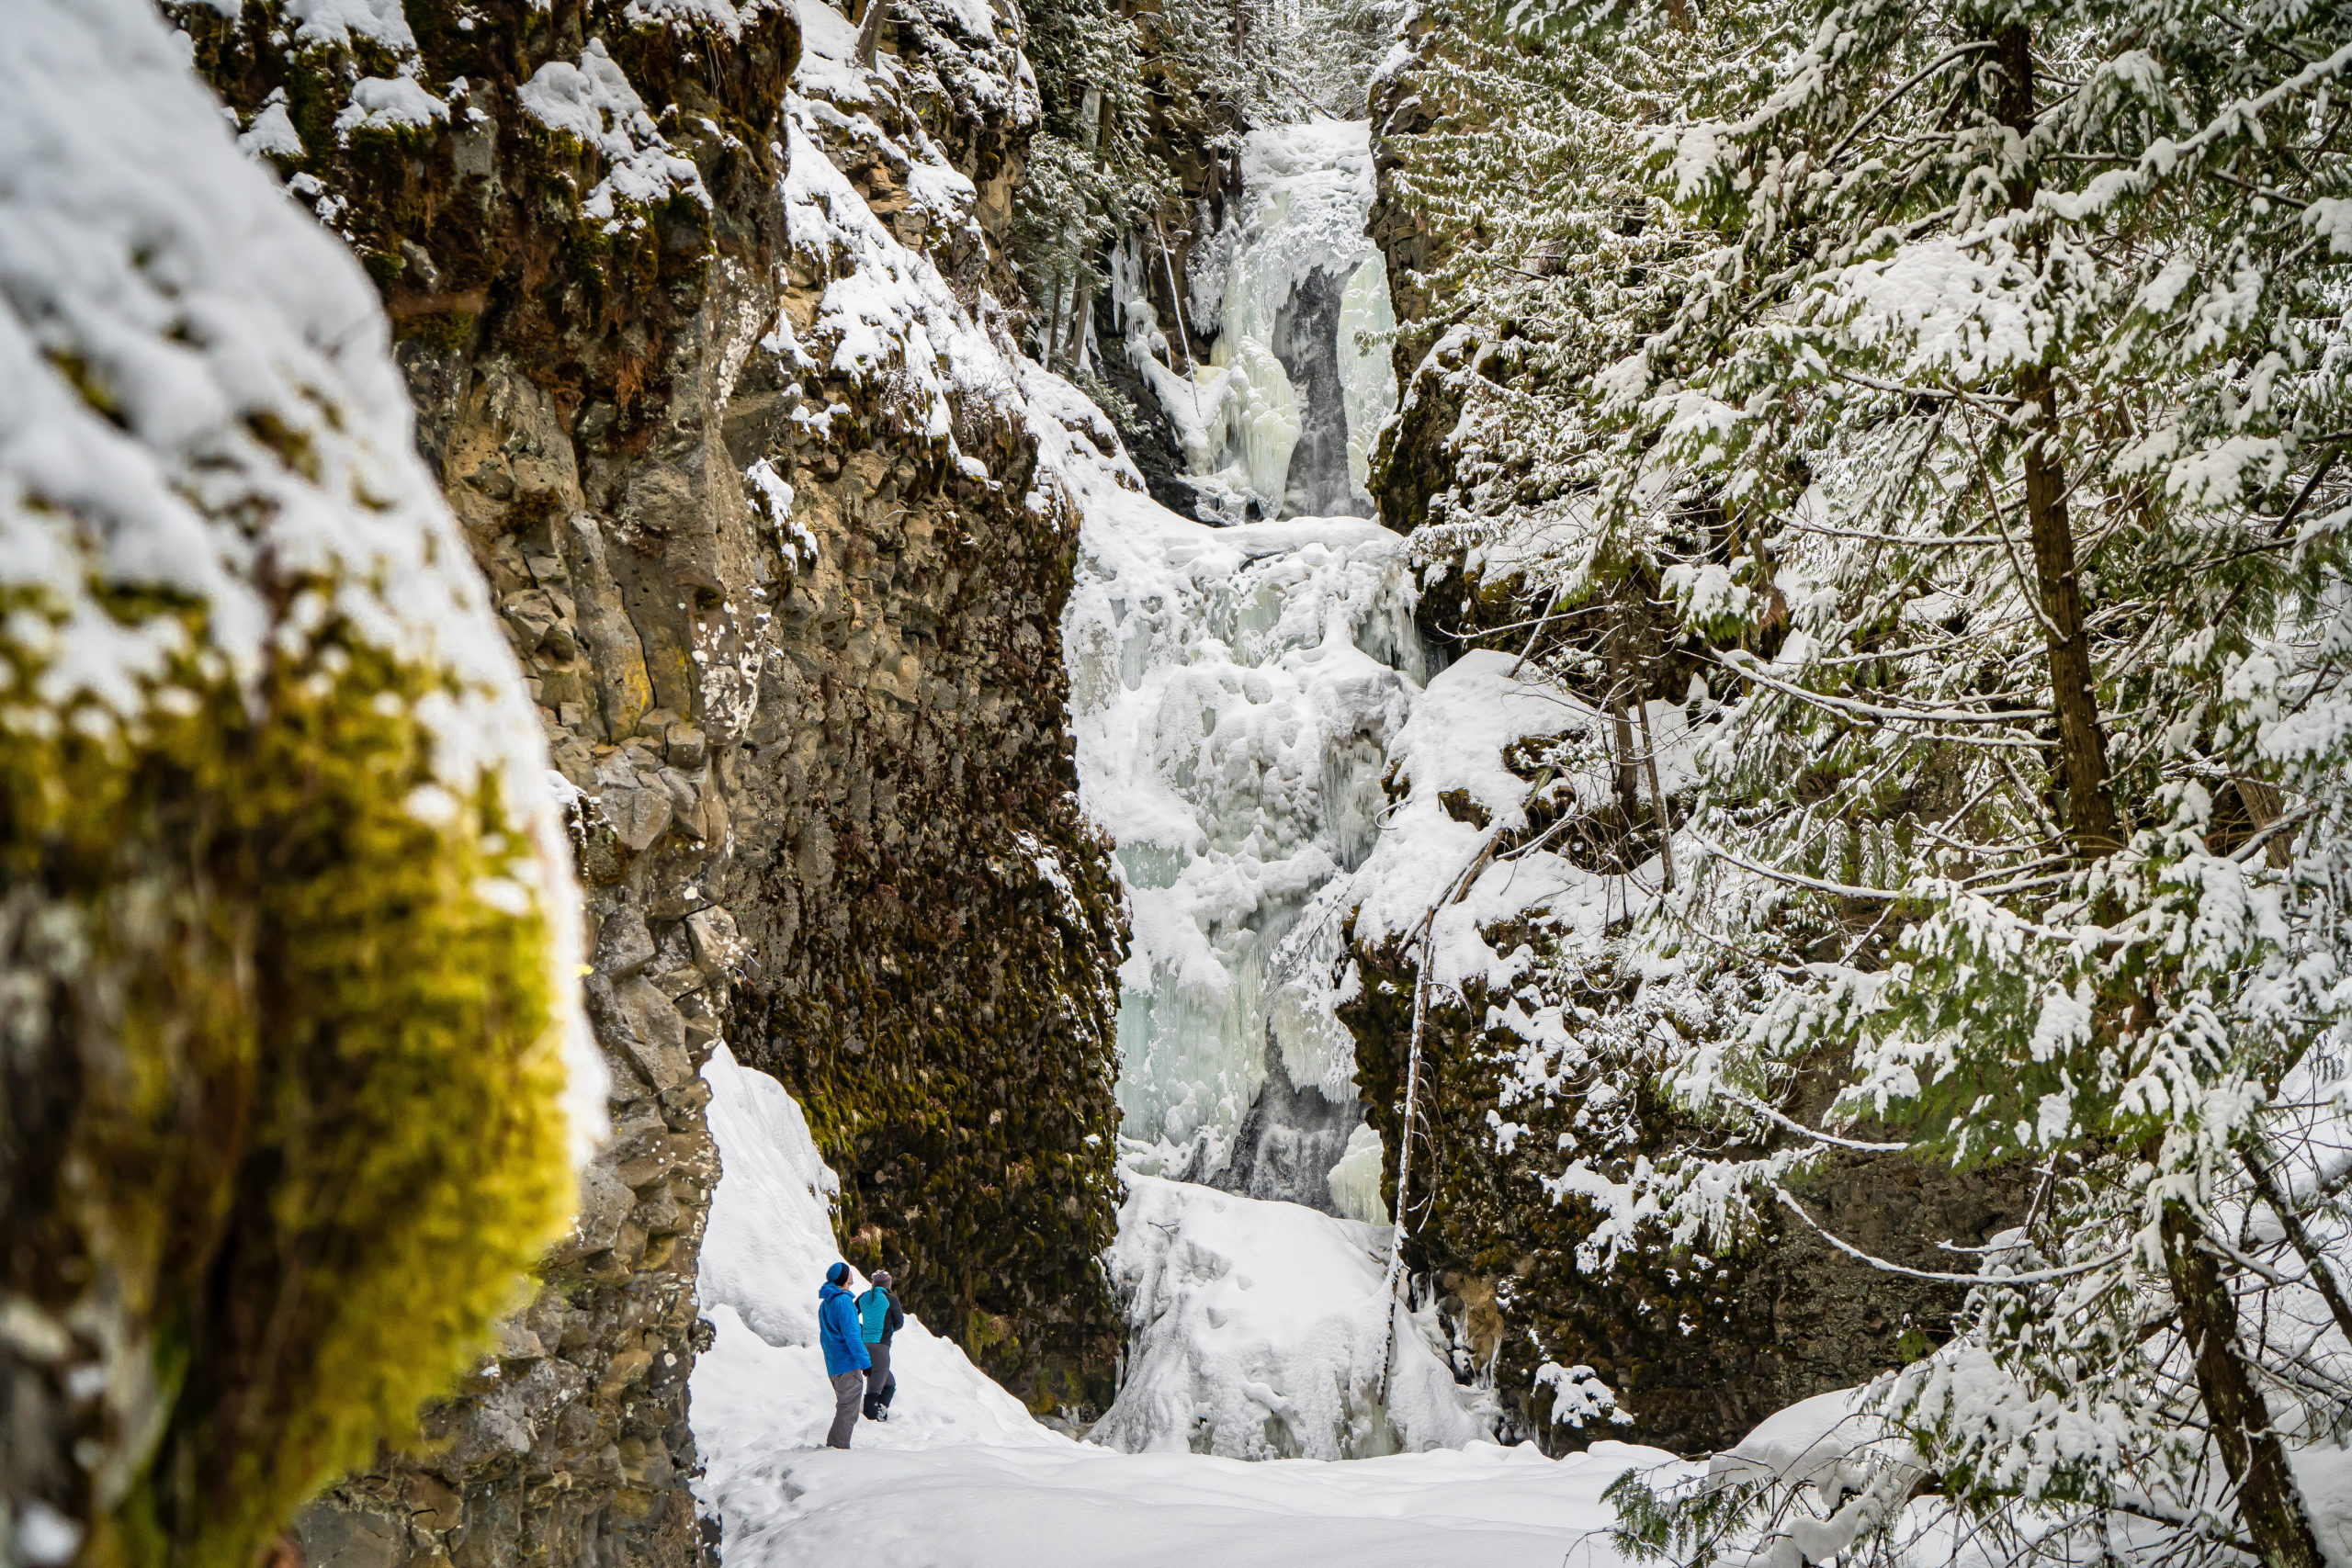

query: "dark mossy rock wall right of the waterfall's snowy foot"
(1340, 917), (2020, 1453)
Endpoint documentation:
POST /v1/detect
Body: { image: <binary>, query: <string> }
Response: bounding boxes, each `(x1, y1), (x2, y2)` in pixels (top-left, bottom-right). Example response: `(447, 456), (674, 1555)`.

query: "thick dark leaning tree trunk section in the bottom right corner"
(2164, 1203), (2324, 1568)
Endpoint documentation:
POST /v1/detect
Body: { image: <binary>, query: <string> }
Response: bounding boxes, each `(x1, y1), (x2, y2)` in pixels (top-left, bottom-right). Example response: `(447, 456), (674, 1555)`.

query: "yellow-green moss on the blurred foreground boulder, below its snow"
(0, 585), (570, 1568)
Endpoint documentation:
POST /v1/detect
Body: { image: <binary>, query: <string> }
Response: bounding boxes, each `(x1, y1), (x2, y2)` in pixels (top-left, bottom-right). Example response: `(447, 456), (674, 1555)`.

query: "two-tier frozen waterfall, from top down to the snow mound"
(1063, 120), (1430, 1220)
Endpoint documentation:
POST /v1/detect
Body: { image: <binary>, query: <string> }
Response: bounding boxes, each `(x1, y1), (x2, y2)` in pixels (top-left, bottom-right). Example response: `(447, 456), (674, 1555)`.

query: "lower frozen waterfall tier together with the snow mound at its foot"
(1023, 305), (1498, 1458)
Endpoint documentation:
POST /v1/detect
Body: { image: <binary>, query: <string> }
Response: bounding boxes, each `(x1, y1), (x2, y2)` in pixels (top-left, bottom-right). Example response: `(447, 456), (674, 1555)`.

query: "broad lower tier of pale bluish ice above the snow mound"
(1058, 404), (1428, 1218)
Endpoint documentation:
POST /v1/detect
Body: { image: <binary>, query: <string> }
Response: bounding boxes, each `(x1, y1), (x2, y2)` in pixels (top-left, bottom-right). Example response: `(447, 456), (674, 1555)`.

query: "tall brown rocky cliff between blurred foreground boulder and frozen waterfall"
(176, 0), (1122, 1568)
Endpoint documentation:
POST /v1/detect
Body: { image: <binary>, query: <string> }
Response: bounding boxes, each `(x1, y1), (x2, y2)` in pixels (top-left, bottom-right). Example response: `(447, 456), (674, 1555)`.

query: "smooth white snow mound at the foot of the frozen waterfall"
(1091, 1176), (1494, 1460)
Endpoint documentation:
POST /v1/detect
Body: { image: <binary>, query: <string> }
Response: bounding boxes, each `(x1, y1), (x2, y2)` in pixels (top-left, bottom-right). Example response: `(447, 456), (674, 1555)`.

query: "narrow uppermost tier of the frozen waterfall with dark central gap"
(1113, 120), (1397, 522)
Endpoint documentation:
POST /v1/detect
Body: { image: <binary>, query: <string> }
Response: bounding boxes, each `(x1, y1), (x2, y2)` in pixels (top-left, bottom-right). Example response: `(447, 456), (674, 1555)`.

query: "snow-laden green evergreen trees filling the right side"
(1401, 0), (2352, 1565)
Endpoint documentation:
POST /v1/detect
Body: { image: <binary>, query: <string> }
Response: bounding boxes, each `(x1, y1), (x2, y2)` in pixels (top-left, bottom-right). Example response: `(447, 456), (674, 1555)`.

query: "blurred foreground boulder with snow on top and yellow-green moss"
(0, 0), (602, 1568)
